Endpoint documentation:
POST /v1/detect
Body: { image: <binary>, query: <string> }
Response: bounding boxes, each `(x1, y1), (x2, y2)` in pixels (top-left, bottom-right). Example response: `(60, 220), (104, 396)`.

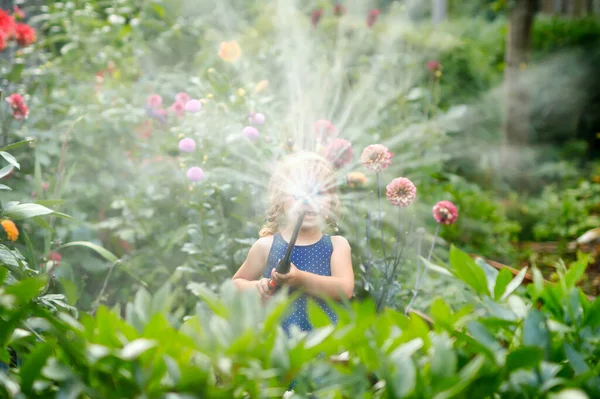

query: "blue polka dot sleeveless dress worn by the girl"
(264, 233), (337, 334)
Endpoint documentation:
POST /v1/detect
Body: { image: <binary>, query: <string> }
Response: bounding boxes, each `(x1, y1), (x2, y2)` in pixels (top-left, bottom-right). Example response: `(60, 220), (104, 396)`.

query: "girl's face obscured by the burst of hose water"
(283, 186), (330, 228)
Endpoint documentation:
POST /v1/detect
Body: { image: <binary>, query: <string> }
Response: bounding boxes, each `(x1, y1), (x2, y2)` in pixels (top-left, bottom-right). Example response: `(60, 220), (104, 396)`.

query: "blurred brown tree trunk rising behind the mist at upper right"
(503, 0), (537, 147)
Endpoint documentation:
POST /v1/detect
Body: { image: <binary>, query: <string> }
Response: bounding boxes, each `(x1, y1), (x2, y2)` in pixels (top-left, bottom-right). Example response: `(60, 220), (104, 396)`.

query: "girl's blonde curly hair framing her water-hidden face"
(259, 151), (340, 237)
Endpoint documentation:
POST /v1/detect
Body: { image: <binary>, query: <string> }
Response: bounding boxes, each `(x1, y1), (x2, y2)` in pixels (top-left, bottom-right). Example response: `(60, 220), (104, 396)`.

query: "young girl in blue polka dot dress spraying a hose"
(233, 152), (354, 334)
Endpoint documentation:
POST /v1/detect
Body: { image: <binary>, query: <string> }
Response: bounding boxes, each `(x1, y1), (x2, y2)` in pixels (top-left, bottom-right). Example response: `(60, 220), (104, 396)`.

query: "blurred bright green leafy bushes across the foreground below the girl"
(0, 248), (600, 398)
